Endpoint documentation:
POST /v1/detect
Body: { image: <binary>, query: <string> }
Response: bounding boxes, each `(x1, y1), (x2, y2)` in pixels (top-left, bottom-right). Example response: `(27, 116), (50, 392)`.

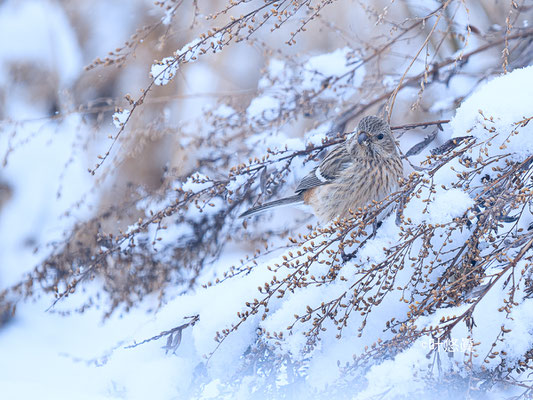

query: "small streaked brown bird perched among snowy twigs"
(240, 116), (403, 222)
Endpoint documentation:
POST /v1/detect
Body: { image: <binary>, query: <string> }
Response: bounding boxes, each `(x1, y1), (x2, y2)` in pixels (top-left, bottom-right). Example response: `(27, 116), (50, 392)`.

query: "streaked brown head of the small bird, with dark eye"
(347, 115), (397, 157)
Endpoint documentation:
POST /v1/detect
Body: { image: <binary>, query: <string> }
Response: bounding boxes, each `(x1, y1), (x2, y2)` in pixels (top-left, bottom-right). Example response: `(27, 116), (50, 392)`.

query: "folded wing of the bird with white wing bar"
(296, 143), (353, 193)
